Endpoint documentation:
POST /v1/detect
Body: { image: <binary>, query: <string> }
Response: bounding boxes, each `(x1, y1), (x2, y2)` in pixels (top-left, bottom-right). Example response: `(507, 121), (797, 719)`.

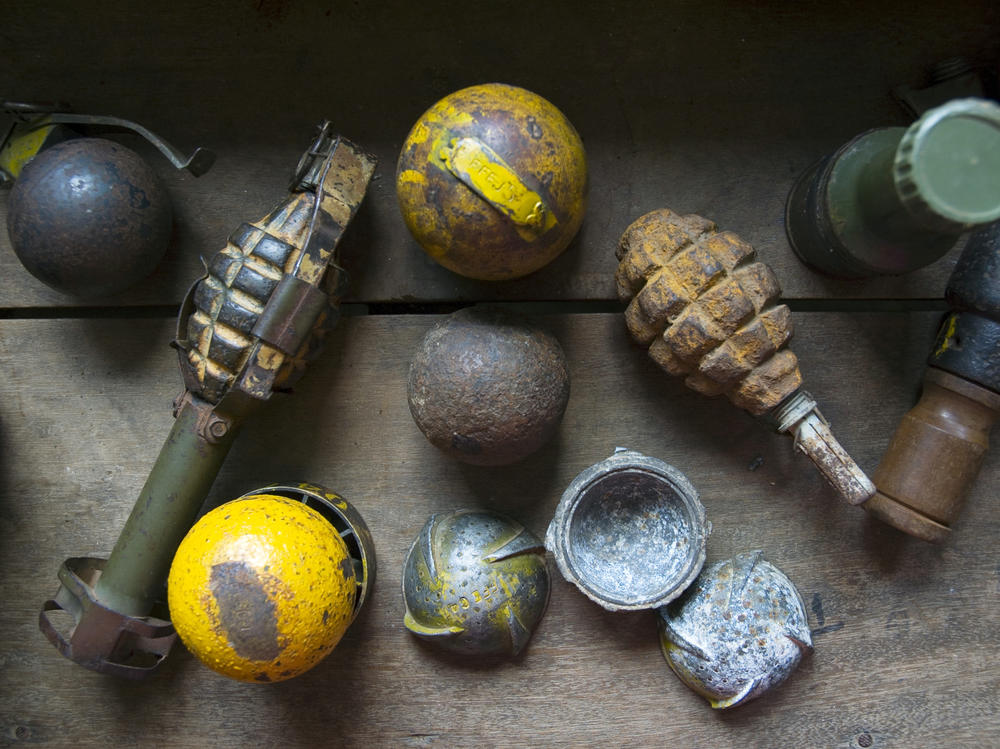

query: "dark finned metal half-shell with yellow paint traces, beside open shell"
(403, 510), (549, 656)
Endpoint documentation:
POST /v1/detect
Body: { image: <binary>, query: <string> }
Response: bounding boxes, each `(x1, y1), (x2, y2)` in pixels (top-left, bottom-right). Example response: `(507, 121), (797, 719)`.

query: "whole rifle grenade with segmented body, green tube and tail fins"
(39, 122), (375, 678)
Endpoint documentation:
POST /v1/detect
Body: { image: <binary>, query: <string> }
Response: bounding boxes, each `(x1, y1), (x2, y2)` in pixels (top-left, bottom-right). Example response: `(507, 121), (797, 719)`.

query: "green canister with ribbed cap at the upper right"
(786, 98), (1000, 278)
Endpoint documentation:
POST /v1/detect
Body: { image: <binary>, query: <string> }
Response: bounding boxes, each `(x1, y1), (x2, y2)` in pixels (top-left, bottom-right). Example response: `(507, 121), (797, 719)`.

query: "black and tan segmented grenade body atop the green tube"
(177, 122), (375, 403)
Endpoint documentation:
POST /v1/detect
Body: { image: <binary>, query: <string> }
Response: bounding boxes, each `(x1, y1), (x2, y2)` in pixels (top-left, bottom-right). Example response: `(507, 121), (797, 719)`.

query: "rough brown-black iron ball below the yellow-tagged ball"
(407, 307), (569, 465)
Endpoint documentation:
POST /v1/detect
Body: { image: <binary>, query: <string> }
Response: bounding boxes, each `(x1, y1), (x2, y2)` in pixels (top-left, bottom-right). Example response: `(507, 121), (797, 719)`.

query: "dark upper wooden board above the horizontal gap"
(0, 0), (1000, 308)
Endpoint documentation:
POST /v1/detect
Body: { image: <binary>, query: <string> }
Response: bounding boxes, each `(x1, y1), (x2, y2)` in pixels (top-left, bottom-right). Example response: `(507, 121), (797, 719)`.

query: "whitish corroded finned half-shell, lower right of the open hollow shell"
(657, 551), (812, 708)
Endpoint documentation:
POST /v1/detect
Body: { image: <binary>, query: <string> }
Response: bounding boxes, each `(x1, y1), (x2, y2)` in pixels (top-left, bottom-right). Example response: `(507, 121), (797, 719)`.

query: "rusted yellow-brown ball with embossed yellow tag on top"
(396, 83), (587, 281)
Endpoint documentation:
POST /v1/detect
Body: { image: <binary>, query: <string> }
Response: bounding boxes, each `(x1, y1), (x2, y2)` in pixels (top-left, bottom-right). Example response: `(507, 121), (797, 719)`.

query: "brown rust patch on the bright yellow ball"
(209, 562), (281, 661)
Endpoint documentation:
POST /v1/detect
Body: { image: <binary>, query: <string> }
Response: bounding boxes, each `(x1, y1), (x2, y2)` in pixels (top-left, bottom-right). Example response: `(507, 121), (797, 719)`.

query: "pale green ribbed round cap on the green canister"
(893, 98), (1000, 234)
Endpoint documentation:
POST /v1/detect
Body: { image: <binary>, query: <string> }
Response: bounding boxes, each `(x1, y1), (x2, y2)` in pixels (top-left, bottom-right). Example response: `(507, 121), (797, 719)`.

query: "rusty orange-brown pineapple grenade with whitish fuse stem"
(615, 209), (875, 504)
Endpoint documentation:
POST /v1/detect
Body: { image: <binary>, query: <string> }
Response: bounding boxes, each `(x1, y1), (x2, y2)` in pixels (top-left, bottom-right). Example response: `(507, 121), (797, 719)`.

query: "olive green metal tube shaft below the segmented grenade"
(95, 398), (239, 617)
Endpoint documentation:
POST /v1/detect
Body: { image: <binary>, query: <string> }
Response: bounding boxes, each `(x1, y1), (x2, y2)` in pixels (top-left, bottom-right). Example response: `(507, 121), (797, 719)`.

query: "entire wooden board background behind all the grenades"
(0, 0), (1000, 748)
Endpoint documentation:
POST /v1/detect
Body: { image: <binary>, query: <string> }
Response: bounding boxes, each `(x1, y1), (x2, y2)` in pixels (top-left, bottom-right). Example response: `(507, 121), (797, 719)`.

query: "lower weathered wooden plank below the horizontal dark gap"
(0, 313), (1000, 749)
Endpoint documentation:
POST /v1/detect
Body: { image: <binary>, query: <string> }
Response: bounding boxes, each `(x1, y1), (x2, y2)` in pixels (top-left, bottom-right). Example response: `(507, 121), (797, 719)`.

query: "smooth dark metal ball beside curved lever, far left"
(7, 138), (172, 297)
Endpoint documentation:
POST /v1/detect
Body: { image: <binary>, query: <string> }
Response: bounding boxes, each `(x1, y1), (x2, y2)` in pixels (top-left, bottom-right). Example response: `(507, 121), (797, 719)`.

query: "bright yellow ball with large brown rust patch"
(167, 494), (357, 682)
